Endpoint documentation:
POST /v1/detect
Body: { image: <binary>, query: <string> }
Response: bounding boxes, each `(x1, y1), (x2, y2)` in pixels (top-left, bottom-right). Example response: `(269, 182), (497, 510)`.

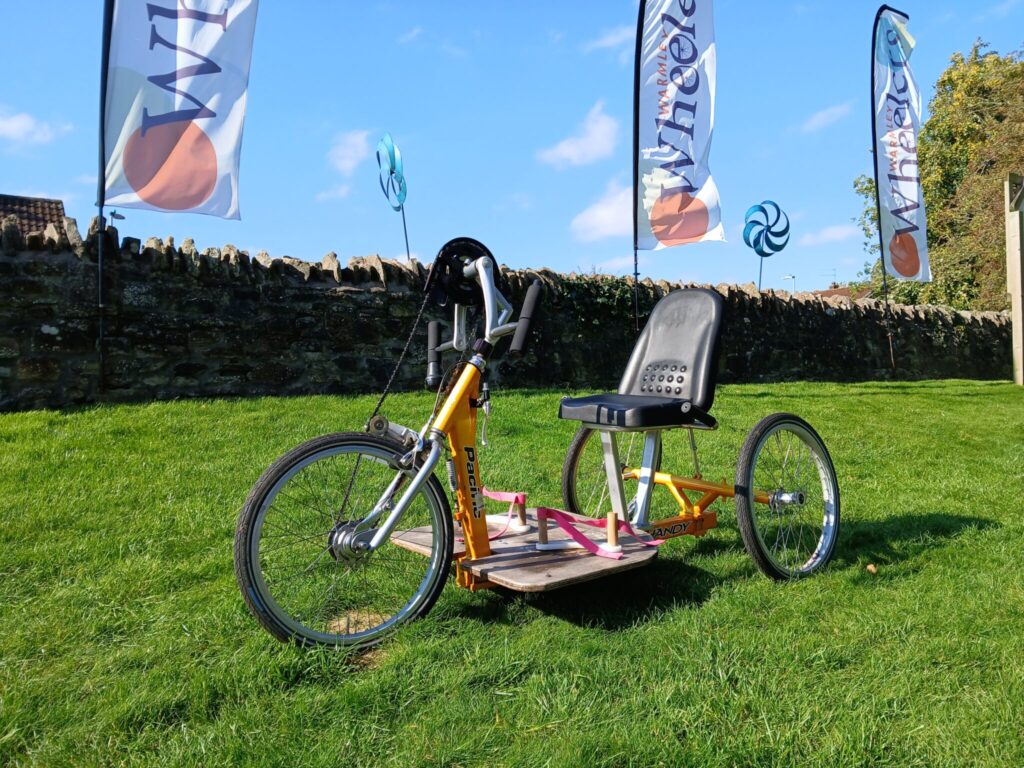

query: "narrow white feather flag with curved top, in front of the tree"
(871, 5), (932, 283)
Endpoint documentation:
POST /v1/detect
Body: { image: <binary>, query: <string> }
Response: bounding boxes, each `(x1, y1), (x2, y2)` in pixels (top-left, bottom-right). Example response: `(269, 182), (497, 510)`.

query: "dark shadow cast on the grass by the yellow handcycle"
(454, 512), (999, 631)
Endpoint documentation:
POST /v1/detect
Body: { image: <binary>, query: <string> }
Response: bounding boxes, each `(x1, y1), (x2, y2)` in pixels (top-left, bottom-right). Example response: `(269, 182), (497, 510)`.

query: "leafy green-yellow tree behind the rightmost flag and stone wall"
(854, 42), (1024, 309)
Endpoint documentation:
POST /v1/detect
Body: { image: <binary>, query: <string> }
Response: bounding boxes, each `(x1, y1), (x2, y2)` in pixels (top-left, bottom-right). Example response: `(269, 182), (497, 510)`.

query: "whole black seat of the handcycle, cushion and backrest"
(558, 288), (723, 429)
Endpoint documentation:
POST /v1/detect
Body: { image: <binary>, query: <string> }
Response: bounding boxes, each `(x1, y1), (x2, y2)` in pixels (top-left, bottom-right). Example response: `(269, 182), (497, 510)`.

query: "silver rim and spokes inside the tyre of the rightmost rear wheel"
(749, 422), (839, 578)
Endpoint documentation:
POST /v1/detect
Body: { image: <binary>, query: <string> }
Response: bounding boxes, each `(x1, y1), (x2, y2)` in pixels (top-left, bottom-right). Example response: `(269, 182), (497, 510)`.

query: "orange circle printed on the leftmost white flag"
(123, 121), (217, 211)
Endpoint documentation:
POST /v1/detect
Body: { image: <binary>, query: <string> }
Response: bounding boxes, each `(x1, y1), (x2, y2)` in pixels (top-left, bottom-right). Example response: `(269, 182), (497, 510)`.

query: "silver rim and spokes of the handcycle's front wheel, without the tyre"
(249, 443), (443, 645)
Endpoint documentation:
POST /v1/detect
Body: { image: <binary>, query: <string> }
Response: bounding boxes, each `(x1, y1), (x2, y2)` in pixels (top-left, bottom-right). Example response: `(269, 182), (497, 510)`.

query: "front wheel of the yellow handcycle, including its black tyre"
(234, 433), (454, 648)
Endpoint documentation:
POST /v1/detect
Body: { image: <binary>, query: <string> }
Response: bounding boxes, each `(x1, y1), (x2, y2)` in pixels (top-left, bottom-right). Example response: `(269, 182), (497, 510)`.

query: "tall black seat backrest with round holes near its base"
(618, 288), (723, 412)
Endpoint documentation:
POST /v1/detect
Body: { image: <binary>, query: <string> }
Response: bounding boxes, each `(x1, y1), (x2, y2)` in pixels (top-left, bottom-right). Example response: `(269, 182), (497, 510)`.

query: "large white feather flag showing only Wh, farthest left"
(98, 0), (258, 219)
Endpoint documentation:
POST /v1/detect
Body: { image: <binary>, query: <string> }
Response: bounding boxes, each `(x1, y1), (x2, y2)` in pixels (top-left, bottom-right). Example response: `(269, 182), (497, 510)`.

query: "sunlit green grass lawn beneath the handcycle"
(0, 381), (1024, 768)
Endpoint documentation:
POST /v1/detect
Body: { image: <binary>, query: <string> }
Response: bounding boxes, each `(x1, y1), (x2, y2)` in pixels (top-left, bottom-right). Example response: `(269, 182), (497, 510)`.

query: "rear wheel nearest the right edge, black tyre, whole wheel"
(736, 414), (840, 581)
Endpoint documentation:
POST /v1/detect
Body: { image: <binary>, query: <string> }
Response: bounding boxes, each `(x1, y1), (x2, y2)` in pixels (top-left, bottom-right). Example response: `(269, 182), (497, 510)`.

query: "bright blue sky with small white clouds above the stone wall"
(0, 0), (1024, 289)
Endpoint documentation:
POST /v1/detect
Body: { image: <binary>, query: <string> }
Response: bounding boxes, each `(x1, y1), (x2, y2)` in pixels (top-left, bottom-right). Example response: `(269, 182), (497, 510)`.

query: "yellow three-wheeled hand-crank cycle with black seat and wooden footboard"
(234, 238), (840, 647)
